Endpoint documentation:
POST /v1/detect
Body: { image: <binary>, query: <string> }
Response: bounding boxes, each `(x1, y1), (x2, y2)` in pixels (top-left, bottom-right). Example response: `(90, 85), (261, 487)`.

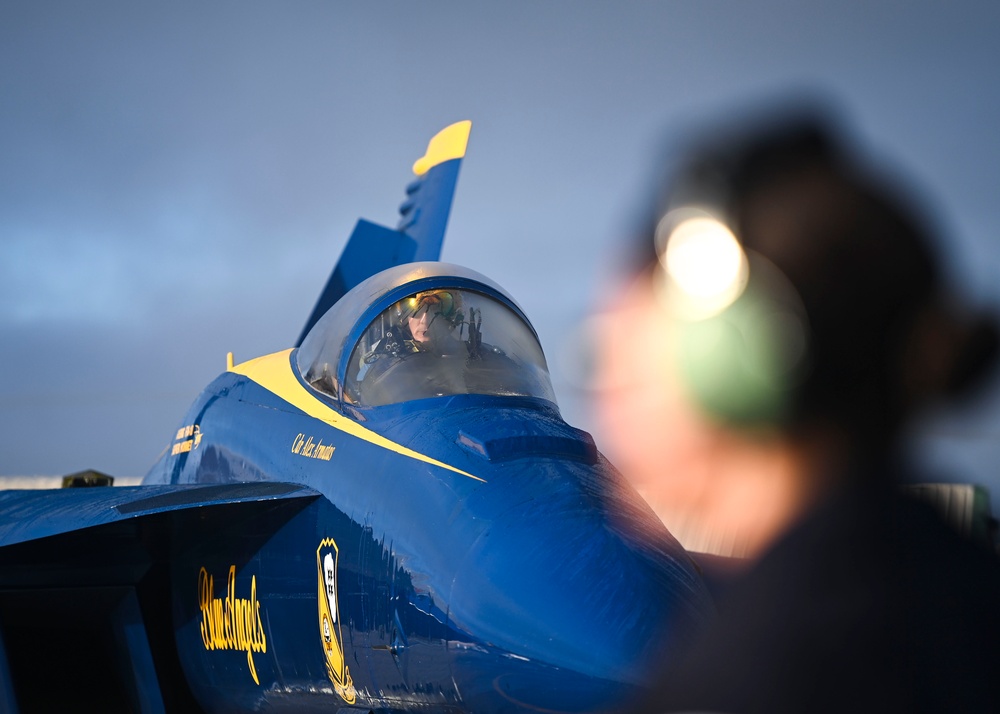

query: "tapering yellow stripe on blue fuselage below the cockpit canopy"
(229, 350), (485, 483)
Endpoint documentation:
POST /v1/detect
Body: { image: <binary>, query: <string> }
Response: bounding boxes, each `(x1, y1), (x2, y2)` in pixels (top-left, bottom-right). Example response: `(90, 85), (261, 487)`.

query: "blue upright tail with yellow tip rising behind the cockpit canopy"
(295, 121), (472, 347)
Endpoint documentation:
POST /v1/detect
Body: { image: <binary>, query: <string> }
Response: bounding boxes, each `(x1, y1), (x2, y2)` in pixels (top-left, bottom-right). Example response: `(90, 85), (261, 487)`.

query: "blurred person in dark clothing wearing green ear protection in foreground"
(612, 107), (1000, 712)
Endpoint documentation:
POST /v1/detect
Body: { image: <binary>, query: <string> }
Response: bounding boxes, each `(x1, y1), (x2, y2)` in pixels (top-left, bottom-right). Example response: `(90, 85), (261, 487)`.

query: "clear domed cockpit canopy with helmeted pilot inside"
(297, 263), (555, 406)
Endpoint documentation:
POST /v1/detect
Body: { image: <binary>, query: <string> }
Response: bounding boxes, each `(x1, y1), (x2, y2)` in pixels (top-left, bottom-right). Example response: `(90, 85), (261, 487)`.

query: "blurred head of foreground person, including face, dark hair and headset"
(597, 103), (997, 552)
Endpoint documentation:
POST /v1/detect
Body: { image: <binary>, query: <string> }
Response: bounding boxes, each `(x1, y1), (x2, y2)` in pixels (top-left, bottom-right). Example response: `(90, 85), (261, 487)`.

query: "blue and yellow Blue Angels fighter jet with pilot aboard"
(0, 122), (711, 713)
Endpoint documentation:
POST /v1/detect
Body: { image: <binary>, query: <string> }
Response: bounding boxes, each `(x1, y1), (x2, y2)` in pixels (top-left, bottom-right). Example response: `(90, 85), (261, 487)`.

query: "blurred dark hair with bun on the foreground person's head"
(666, 112), (998, 445)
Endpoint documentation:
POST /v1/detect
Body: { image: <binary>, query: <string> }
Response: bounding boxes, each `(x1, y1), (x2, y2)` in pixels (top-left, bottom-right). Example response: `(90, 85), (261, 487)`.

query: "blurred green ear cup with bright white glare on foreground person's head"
(654, 207), (810, 427)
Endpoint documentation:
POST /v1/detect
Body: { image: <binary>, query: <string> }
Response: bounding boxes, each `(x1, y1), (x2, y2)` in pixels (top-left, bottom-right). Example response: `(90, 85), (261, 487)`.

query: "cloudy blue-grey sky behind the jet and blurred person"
(0, 0), (1000, 512)
